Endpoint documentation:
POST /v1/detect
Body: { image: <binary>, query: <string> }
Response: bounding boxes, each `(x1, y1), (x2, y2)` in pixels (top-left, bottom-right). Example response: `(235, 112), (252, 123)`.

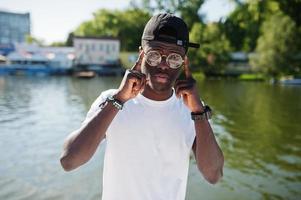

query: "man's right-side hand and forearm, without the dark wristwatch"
(175, 57), (224, 184)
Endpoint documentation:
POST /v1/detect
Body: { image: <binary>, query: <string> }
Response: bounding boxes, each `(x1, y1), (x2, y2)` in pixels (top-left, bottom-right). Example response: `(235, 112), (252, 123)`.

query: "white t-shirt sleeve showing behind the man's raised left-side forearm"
(82, 89), (117, 125)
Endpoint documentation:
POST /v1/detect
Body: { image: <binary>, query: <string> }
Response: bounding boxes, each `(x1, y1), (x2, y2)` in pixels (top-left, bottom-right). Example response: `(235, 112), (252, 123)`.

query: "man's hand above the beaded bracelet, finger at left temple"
(115, 50), (146, 103)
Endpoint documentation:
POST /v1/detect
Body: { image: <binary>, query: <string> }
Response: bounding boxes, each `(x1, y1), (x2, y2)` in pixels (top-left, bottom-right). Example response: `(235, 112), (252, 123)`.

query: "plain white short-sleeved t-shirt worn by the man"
(84, 90), (195, 200)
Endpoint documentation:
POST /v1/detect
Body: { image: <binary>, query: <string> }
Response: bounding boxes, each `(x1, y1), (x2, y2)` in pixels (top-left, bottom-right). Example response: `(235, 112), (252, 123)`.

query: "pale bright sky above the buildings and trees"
(0, 0), (234, 44)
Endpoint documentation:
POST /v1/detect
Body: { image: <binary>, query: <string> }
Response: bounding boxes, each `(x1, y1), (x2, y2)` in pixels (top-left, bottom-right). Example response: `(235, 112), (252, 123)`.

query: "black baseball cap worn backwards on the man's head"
(141, 13), (200, 52)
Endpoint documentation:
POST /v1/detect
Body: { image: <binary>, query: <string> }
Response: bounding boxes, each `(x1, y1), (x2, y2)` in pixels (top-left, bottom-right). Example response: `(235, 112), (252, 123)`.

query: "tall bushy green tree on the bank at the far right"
(250, 12), (300, 77)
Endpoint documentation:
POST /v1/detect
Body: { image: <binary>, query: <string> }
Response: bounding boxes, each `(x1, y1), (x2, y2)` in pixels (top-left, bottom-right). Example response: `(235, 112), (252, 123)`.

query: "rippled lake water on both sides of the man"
(0, 76), (301, 200)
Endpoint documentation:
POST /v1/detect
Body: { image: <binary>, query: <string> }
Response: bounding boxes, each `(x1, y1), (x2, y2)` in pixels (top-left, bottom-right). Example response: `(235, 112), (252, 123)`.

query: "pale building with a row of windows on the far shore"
(73, 36), (120, 66)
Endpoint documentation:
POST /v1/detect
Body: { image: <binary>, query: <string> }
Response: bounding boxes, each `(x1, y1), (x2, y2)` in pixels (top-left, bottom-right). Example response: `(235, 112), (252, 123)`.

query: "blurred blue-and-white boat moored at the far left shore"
(0, 44), (74, 75)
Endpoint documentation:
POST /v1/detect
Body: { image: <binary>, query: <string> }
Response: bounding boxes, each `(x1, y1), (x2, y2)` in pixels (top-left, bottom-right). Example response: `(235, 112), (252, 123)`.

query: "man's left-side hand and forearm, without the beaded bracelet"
(60, 52), (146, 171)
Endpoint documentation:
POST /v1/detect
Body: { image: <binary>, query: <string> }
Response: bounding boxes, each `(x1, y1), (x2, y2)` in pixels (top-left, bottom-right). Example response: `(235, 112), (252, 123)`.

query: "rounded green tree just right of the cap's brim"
(189, 23), (231, 74)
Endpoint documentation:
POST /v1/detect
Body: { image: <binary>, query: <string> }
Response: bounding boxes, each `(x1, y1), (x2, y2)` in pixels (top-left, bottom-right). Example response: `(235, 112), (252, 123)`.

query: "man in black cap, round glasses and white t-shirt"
(61, 14), (224, 200)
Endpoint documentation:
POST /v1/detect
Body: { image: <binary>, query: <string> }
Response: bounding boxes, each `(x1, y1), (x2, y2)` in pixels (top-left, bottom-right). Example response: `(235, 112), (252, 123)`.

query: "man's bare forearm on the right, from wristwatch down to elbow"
(192, 120), (224, 184)
